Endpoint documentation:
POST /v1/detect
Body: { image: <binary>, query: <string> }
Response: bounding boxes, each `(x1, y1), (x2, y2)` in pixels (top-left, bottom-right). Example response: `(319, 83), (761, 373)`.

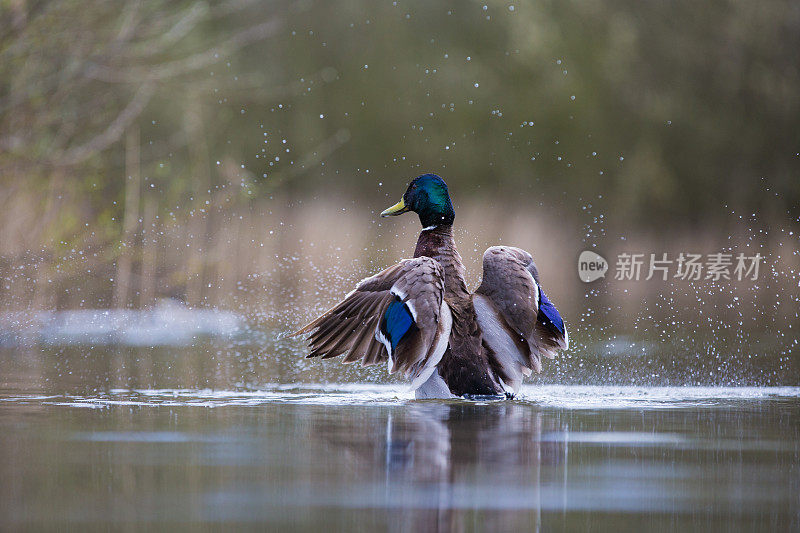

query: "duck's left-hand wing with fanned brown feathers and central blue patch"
(295, 257), (452, 388)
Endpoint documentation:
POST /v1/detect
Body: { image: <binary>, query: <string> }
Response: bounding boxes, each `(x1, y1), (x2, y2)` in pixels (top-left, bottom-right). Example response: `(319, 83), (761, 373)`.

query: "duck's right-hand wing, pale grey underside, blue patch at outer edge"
(473, 246), (569, 391)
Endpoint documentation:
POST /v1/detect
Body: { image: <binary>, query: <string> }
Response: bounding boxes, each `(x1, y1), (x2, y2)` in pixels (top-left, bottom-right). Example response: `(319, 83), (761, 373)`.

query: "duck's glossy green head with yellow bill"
(381, 174), (456, 228)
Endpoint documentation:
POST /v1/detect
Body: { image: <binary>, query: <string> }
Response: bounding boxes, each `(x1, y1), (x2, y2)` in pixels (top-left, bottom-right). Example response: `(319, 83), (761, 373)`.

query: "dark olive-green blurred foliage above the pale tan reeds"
(0, 0), (800, 308)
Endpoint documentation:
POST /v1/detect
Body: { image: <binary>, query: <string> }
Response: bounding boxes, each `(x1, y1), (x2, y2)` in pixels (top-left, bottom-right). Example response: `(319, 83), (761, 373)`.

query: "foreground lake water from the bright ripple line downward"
(0, 380), (800, 532)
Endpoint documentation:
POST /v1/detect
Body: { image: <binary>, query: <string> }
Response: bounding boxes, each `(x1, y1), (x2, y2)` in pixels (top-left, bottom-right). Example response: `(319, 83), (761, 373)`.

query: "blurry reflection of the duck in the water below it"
(316, 402), (566, 531)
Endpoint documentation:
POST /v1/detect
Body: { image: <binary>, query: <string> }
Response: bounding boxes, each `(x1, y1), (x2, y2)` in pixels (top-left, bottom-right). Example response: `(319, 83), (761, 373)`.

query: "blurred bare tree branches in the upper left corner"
(0, 1), (282, 171)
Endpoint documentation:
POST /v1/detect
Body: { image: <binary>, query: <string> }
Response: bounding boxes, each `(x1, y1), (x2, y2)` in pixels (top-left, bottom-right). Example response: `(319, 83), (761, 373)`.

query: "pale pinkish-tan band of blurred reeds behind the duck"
(0, 187), (800, 330)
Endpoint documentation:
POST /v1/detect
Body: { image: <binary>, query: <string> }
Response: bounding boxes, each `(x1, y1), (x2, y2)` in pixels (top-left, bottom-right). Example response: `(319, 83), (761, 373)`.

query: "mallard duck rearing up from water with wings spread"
(295, 174), (569, 399)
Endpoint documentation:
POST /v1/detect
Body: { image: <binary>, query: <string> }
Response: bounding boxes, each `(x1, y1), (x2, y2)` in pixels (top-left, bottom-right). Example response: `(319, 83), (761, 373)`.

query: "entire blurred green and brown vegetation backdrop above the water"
(0, 0), (800, 344)
